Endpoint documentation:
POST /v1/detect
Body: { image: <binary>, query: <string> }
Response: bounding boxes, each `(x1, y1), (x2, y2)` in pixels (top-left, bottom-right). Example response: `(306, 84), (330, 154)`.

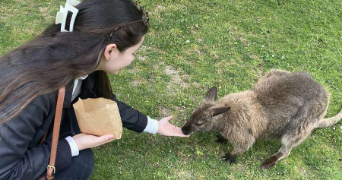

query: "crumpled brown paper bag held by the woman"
(73, 98), (122, 139)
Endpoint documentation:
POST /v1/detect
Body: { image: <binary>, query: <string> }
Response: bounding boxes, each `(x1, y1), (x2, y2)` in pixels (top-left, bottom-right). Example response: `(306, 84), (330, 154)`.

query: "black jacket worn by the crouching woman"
(0, 72), (147, 180)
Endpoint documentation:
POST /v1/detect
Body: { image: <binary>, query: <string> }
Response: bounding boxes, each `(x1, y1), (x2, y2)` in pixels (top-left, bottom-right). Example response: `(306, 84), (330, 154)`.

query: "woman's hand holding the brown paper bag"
(72, 133), (114, 151)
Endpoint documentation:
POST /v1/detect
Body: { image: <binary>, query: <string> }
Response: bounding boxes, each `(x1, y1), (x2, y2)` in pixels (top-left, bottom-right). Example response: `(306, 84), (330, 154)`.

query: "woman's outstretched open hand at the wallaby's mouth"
(158, 116), (190, 137)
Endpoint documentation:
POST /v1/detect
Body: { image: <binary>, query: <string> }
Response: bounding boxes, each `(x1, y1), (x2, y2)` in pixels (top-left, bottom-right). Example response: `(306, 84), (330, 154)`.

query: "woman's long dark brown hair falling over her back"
(0, 0), (148, 124)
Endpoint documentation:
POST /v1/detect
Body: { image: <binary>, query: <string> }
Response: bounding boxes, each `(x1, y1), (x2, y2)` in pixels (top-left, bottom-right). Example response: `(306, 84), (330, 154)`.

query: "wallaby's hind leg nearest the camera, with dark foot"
(261, 127), (313, 169)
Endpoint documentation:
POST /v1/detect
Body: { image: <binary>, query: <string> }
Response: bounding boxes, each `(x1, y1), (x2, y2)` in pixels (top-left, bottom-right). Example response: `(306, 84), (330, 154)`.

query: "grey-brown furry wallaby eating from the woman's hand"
(182, 70), (342, 169)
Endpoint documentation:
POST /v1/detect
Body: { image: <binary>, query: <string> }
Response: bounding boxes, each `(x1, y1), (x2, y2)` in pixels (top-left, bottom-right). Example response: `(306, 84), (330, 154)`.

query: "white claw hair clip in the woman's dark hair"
(55, 0), (80, 32)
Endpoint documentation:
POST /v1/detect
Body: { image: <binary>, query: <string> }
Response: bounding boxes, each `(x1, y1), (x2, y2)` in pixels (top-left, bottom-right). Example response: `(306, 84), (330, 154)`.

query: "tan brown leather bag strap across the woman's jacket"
(46, 86), (65, 180)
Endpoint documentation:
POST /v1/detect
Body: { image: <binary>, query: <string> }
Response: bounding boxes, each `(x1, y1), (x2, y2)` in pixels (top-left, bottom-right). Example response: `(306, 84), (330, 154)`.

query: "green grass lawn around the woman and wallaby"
(0, 0), (342, 180)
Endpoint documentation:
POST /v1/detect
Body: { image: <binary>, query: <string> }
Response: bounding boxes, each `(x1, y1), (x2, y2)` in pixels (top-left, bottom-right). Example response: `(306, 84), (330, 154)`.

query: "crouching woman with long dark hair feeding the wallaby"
(0, 0), (186, 180)
